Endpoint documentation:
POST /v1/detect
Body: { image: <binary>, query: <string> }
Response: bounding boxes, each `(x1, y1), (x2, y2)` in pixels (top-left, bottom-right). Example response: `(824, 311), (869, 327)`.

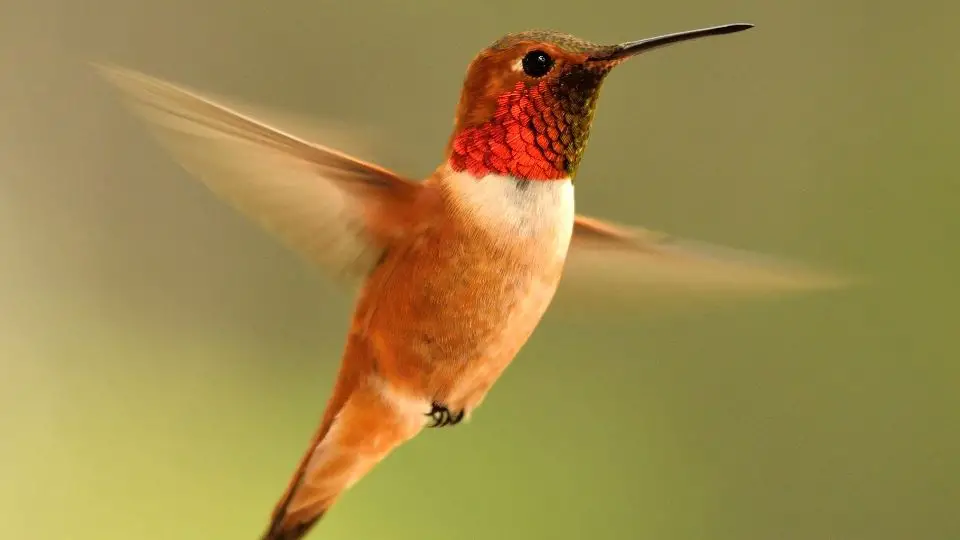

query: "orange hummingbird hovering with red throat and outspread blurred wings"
(96, 24), (841, 540)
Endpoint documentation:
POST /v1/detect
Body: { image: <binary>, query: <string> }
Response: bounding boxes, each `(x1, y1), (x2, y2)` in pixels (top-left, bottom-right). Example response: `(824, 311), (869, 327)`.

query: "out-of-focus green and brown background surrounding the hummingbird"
(0, 0), (960, 540)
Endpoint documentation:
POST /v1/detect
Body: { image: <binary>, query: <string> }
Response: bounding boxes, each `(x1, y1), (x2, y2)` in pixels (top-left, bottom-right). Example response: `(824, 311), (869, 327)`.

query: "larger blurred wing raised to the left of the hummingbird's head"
(97, 65), (422, 277)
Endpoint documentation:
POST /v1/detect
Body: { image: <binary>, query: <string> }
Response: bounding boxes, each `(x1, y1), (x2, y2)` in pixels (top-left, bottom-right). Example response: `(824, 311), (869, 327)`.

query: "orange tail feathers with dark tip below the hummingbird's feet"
(262, 375), (429, 540)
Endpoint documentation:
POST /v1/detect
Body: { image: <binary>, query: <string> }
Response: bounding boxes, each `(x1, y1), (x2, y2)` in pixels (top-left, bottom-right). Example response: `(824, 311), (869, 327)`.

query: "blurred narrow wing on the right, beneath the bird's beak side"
(558, 216), (845, 306)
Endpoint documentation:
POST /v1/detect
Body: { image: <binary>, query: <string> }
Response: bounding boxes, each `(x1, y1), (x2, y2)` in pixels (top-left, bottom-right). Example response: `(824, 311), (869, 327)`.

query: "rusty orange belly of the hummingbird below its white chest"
(354, 200), (565, 413)
